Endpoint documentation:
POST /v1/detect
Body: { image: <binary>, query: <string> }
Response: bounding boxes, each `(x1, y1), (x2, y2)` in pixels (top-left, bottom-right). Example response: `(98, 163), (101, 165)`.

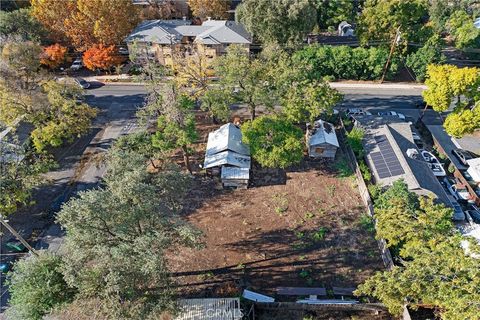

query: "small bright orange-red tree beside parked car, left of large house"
(83, 44), (124, 71)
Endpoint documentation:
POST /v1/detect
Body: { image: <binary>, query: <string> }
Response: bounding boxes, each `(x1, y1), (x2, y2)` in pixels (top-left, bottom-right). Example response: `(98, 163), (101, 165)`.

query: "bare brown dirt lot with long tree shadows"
(169, 113), (383, 297)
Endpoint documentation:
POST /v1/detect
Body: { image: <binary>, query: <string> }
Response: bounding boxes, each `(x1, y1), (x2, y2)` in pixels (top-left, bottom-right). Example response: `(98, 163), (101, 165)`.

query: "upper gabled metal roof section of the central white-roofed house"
(206, 123), (250, 155)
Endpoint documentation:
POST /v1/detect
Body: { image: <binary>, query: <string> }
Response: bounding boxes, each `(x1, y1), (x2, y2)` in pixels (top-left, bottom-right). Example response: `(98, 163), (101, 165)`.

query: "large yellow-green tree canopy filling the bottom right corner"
(357, 181), (480, 320)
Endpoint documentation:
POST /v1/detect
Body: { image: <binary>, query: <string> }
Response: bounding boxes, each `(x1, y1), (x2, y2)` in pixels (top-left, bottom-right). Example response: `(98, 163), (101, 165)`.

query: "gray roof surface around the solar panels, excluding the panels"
(356, 116), (449, 205)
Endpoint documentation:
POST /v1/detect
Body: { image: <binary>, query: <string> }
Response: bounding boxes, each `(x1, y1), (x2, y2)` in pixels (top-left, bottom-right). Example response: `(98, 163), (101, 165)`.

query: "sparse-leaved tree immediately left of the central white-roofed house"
(148, 85), (198, 172)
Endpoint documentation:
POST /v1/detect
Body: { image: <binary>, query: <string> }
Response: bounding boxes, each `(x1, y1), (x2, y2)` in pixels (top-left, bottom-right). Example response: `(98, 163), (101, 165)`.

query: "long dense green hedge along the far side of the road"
(293, 45), (399, 80)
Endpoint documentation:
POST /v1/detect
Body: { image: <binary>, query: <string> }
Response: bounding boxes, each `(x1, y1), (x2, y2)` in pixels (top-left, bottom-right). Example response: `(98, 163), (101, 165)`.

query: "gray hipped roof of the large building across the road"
(125, 20), (251, 44)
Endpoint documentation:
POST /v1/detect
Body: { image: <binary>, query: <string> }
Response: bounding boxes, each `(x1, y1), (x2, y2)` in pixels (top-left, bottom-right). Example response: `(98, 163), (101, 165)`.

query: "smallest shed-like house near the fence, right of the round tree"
(306, 120), (340, 159)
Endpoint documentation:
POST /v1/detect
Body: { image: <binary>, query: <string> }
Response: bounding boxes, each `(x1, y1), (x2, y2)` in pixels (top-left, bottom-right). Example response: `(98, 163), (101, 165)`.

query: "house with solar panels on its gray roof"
(355, 115), (451, 206)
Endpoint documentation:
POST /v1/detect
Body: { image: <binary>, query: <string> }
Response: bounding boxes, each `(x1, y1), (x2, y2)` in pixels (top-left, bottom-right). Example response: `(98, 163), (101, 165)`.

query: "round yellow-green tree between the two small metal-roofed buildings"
(242, 116), (304, 168)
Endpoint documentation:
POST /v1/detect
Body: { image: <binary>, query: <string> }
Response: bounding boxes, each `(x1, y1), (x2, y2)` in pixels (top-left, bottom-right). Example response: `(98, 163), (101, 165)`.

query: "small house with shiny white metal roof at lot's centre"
(203, 123), (251, 188)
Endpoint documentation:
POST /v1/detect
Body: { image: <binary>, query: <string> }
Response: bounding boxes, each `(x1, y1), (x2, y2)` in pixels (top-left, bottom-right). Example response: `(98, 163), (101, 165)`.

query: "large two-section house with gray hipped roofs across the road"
(125, 19), (252, 65)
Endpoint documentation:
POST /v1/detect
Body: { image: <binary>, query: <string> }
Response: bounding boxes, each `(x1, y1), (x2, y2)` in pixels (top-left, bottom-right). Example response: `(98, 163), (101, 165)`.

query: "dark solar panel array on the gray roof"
(370, 135), (405, 179)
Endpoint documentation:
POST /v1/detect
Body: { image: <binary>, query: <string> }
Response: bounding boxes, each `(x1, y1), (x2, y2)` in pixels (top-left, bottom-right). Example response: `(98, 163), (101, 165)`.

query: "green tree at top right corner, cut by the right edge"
(447, 10), (480, 49)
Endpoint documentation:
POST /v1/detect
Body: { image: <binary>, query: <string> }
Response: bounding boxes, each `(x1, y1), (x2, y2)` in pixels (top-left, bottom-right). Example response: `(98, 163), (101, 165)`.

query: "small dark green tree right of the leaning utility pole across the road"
(406, 35), (446, 82)
